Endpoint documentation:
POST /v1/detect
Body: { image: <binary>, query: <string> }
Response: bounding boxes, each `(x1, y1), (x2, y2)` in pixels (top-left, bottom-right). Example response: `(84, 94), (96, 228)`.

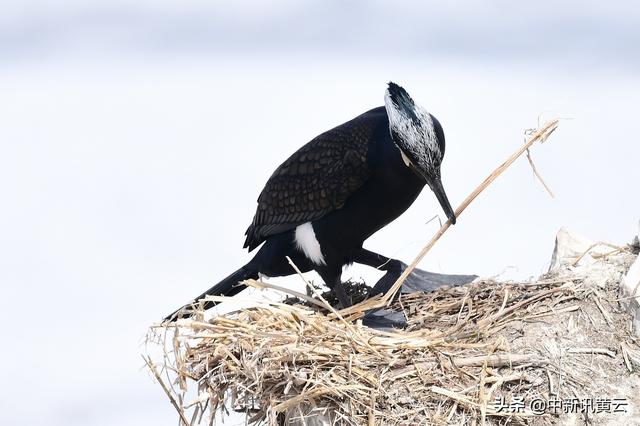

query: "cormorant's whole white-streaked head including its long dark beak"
(384, 82), (456, 224)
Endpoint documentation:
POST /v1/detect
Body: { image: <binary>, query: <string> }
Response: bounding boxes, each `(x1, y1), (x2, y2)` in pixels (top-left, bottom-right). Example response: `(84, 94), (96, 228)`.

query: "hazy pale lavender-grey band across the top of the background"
(0, 0), (640, 67)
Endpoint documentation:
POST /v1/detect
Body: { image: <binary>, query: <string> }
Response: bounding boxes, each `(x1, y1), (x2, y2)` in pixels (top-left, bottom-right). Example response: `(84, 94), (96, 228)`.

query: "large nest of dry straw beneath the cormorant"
(146, 251), (640, 425)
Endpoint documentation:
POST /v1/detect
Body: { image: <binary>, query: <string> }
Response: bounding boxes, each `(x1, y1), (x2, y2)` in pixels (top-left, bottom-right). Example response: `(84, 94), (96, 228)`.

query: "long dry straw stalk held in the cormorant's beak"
(370, 120), (559, 307)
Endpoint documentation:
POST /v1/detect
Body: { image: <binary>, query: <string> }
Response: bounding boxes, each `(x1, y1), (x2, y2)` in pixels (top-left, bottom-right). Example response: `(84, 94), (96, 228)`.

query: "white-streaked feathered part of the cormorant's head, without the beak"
(384, 83), (442, 173)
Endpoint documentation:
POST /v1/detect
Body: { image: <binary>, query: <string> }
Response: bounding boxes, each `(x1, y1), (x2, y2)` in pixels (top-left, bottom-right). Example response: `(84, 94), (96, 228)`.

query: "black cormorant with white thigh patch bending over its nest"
(167, 82), (456, 319)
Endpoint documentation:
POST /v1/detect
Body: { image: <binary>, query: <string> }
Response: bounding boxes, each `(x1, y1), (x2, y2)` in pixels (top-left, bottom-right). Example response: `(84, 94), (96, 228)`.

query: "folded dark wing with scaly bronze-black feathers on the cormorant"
(244, 109), (387, 251)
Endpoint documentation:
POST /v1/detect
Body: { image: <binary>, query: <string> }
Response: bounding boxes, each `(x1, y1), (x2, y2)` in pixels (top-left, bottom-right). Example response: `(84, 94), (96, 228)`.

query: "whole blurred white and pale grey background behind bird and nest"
(0, 0), (640, 426)
